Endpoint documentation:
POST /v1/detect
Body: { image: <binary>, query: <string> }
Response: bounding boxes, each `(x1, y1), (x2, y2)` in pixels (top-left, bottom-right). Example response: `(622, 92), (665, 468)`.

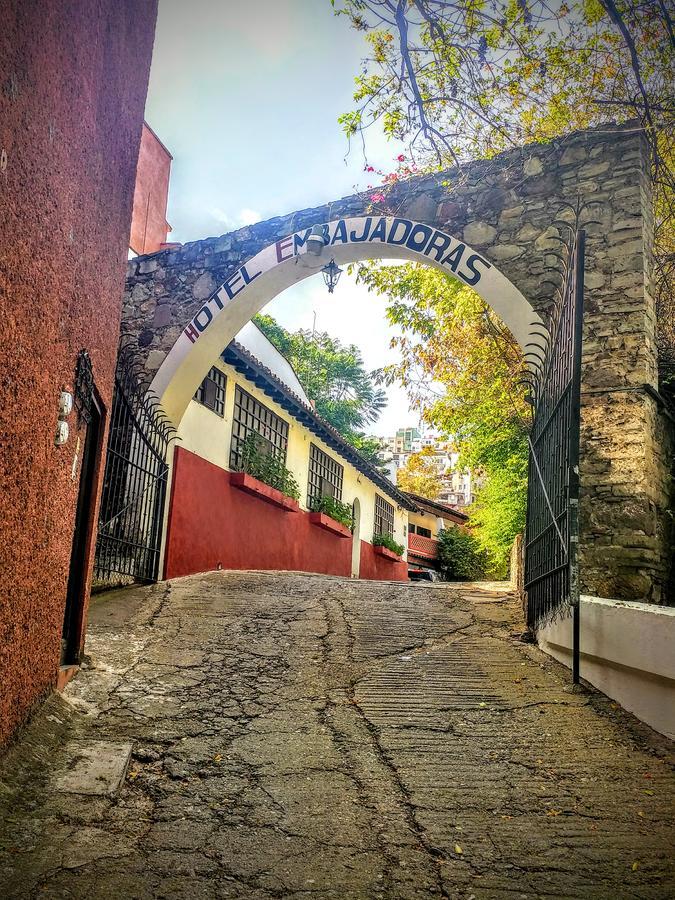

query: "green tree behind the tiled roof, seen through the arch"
(254, 315), (387, 463)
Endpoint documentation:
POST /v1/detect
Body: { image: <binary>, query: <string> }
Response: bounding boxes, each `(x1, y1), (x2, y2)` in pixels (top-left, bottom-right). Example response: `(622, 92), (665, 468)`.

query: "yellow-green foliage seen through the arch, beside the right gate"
(359, 263), (530, 577)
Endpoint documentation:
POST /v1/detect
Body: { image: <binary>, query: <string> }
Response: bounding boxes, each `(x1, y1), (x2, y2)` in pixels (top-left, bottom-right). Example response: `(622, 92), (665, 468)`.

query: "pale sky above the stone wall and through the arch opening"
(145, 0), (418, 436)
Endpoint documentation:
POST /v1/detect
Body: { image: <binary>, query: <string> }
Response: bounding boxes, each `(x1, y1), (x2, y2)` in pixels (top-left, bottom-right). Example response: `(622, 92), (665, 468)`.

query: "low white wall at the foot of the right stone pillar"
(537, 597), (675, 739)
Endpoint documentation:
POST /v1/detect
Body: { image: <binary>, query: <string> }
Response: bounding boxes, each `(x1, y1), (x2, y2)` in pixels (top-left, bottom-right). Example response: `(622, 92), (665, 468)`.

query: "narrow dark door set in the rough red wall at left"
(61, 396), (102, 666)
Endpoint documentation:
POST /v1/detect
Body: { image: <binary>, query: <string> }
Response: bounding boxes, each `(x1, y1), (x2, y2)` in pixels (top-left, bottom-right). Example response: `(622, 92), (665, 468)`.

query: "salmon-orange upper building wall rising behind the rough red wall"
(129, 124), (171, 253)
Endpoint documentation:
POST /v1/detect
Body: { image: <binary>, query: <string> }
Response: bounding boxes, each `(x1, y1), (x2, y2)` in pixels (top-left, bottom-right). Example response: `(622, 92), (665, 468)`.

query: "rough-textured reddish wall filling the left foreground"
(0, 0), (156, 743)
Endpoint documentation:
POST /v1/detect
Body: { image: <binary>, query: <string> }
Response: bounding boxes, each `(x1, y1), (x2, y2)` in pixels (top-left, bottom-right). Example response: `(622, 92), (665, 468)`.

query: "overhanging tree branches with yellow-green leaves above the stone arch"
(331, 0), (675, 371)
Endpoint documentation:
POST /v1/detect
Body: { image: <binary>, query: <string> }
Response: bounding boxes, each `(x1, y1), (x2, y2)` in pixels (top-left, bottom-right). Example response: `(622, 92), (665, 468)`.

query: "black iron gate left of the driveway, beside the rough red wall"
(94, 348), (175, 587)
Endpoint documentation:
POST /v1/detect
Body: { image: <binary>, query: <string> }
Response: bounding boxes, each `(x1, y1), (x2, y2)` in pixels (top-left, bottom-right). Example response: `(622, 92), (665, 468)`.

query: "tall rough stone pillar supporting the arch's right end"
(572, 133), (668, 602)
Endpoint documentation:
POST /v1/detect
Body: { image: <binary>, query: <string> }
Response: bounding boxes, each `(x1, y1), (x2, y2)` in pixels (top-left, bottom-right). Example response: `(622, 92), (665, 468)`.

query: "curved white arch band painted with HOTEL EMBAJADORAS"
(150, 216), (543, 425)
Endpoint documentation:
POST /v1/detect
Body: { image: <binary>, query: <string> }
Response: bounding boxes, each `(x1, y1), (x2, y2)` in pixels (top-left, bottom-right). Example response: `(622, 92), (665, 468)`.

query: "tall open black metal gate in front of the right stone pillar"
(525, 221), (585, 681)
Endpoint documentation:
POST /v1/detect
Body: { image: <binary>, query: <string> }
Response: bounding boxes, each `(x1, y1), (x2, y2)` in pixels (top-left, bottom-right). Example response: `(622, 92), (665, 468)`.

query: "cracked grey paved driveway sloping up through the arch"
(0, 572), (675, 900)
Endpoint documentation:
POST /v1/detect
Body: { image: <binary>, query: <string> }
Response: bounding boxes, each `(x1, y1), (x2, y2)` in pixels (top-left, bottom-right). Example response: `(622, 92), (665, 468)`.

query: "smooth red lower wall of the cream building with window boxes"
(164, 447), (407, 580)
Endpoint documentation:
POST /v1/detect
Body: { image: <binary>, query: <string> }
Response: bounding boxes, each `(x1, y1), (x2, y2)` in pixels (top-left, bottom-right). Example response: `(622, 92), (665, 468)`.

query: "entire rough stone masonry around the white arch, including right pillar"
(122, 126), (671, 602)
